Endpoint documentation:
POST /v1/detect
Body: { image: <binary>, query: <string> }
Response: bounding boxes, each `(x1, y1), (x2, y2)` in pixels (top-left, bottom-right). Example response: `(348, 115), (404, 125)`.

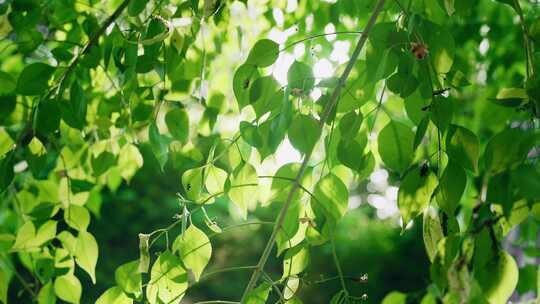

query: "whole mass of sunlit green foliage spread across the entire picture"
(0, 0), (540, 304)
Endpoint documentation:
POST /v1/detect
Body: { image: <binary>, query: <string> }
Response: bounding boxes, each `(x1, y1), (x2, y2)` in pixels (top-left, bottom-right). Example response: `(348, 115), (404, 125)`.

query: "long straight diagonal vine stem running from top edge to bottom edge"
(241, 0), (385, 303)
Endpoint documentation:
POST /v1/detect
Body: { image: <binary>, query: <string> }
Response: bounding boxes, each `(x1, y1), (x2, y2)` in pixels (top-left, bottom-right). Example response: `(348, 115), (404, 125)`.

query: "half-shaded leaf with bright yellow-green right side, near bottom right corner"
(475, 251), (519, 304)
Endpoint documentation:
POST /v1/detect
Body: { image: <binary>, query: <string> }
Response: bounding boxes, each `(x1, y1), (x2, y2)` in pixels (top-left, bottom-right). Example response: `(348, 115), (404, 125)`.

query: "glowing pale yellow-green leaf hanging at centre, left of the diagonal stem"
(229, 162), (258, 219)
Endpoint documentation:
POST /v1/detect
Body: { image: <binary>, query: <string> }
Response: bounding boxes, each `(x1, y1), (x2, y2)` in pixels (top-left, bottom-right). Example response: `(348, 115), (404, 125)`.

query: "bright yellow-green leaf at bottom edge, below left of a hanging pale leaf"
(146, 251), (188, 304)
